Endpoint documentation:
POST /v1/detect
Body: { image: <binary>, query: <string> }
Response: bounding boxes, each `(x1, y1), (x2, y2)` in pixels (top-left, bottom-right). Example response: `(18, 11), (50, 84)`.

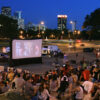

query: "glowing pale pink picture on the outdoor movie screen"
(12, 39), (42, 59)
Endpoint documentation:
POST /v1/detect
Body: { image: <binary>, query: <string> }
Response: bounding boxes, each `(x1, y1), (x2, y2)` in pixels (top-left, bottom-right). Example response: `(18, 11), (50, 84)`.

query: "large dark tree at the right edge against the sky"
(82, 8), (100, 39)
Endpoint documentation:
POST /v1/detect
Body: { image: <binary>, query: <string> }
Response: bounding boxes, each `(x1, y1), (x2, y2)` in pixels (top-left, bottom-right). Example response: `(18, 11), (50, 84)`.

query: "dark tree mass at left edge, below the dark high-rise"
(0, 15), (18, 38)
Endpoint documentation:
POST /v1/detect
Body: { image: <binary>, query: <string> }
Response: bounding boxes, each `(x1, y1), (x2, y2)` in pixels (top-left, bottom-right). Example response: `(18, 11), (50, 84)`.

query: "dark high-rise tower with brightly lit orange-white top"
(57, 15), (67, 31)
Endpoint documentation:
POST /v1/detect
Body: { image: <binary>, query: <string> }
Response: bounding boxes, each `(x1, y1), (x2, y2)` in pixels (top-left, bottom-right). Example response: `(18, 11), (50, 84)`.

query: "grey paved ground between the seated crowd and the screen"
(0, 53), (96, 74)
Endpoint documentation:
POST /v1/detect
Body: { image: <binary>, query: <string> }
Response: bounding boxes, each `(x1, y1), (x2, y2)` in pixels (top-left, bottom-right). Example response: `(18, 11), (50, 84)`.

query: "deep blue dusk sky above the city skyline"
(0, 0), (100, 29)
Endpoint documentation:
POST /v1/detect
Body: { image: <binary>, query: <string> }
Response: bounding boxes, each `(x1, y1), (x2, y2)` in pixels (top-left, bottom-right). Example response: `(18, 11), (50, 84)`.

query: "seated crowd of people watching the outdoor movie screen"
(0, 52), (100, 100)
